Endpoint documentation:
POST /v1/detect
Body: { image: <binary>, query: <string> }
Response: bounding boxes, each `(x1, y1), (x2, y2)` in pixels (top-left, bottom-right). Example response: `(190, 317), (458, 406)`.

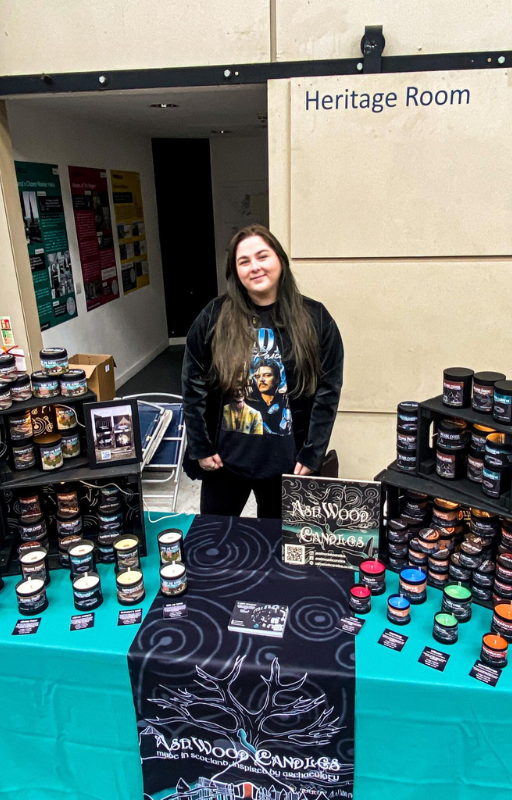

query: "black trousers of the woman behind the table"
(201, 467), (281, 519)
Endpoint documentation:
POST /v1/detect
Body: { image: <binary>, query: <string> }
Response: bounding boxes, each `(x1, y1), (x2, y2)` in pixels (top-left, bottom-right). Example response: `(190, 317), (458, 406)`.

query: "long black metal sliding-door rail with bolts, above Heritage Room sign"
(0, 50), (512, 97)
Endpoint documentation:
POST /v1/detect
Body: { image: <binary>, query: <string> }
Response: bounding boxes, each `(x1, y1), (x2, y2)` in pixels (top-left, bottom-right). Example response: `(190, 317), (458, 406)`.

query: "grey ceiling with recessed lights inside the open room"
(9, 84), (267, 138)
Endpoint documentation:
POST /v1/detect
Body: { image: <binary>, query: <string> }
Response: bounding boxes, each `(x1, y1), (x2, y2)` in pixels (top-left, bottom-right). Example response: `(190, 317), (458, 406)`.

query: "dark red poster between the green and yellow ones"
(69, 167), (119, 311)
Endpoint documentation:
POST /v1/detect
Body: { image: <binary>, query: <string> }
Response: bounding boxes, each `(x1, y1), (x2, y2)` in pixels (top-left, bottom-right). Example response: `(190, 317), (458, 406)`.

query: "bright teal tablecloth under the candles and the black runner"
(0, 512), (512, 800)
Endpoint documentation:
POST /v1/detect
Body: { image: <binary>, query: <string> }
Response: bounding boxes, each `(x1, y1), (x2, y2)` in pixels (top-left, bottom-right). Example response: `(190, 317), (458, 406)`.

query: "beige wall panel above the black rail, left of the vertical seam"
(0, 0), (270, 75)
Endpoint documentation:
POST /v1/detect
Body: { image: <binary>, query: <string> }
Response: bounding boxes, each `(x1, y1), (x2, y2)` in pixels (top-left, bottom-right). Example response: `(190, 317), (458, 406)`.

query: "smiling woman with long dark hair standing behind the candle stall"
(182, 225), (343, 518)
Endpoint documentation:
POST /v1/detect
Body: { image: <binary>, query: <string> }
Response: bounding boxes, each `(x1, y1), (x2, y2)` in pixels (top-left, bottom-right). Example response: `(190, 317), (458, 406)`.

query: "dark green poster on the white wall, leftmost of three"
(15, 161), (77, 331)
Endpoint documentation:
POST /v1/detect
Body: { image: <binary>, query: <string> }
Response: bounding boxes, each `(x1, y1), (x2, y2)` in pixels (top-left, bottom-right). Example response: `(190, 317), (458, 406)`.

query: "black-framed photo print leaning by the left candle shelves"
(84, 399), (142, 469)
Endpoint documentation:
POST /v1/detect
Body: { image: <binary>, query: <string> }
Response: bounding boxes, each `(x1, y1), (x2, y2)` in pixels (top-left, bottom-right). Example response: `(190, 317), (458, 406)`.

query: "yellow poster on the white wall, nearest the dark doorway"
(110, 169), (149, 294)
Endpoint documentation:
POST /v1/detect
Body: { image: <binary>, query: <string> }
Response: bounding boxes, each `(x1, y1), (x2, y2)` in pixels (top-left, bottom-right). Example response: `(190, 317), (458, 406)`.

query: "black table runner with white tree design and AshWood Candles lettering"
(128, 516), (355, 800)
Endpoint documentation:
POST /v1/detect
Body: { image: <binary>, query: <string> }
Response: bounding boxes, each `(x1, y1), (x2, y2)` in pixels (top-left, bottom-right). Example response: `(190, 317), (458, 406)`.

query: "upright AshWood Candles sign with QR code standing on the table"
(283, 475), (380, 570)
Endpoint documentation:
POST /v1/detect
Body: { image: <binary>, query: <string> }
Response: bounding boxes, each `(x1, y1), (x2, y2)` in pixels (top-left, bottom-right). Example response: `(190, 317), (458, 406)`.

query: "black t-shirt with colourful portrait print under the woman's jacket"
(218, 305), (296, 478)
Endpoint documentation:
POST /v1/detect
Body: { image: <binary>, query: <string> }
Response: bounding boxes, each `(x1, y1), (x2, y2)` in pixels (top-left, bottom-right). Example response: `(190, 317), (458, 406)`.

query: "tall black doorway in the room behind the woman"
(152, 139), (217, 338)
